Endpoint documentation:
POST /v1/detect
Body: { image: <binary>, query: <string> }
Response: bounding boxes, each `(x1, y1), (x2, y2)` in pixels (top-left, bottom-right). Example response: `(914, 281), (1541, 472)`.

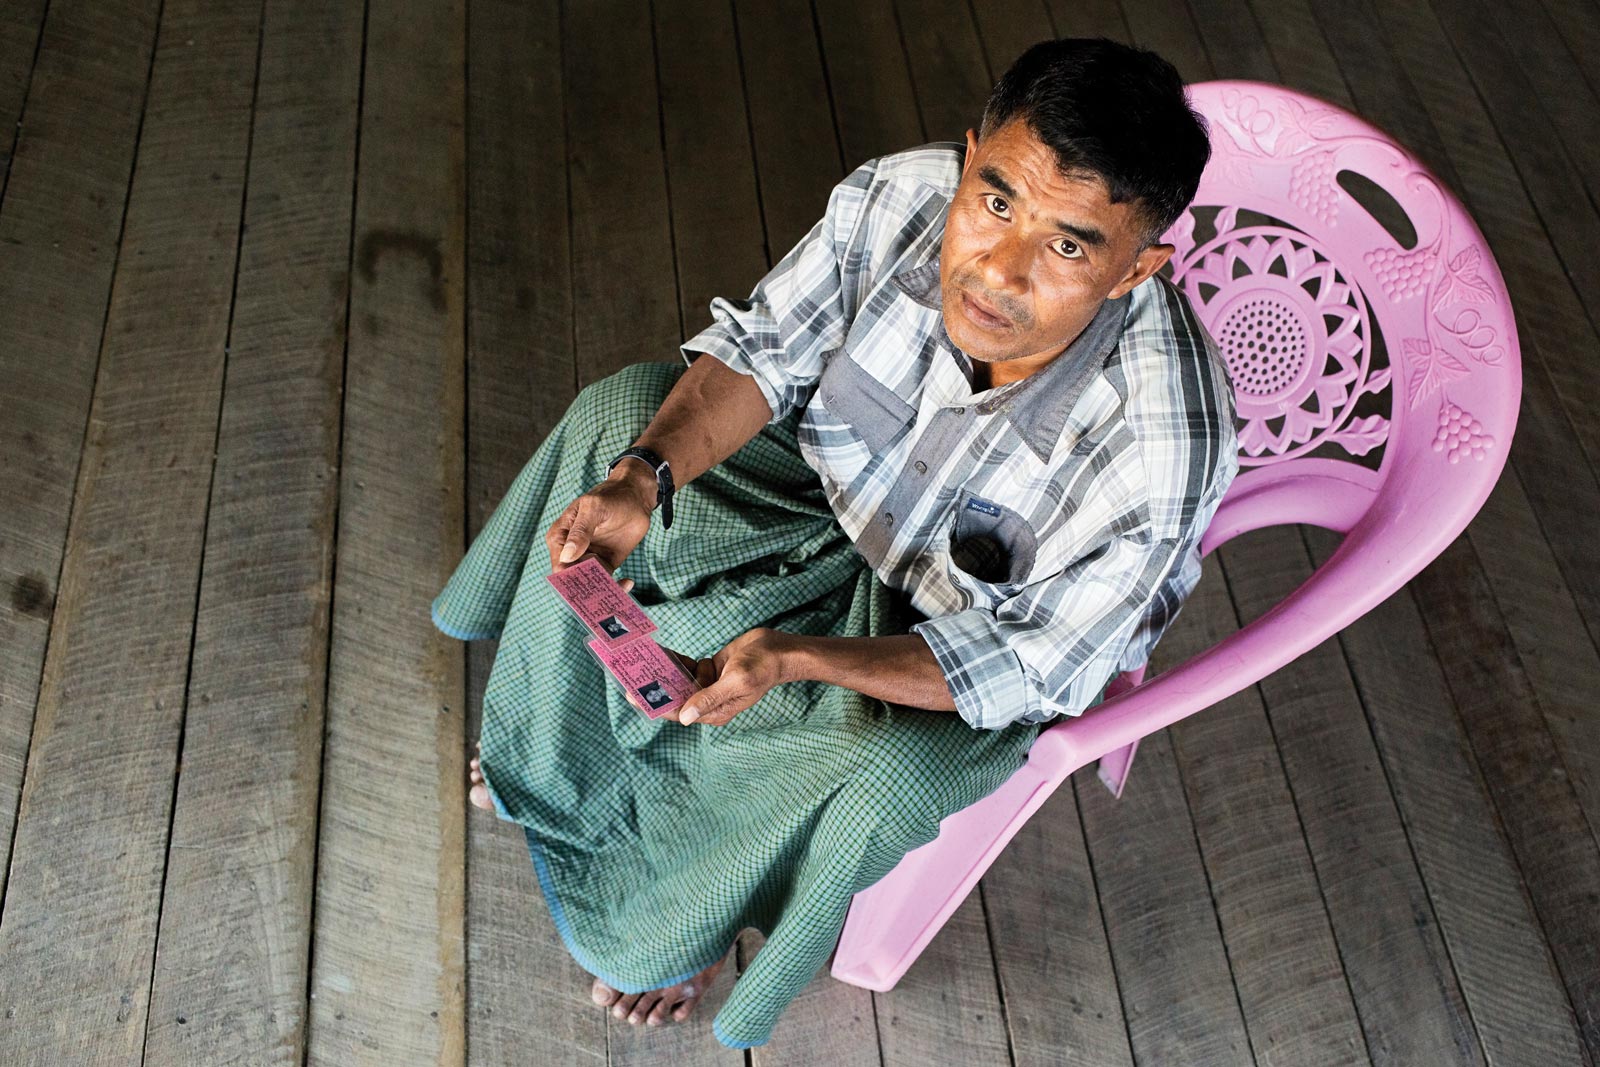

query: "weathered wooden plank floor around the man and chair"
(0, 0), (1600, 1067)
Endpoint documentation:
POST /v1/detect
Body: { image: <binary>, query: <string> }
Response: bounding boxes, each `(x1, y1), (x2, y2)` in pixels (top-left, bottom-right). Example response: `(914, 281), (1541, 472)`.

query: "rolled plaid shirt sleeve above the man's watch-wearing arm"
(678, 158), (877, 422)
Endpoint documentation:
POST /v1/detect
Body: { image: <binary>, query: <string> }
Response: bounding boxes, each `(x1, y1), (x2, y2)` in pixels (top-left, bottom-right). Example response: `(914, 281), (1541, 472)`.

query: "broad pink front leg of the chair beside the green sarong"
(832, 763), (1054, 992)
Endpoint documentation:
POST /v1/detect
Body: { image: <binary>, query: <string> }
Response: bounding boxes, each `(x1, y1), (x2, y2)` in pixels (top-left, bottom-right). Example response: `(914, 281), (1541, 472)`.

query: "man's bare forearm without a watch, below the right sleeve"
(782, 633), (955, 712)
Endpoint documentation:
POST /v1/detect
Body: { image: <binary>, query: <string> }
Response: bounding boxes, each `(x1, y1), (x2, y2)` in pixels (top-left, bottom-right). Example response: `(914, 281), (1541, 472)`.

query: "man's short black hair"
(978, 37), (1211, 248)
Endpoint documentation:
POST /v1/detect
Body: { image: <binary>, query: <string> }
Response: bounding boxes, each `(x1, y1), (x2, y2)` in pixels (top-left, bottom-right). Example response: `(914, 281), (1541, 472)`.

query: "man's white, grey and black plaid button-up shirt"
(682, 142), (1238, 729)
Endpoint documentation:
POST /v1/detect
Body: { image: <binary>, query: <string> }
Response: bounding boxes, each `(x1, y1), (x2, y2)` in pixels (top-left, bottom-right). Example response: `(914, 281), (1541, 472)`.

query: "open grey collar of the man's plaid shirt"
(894, 254), (1130, 462)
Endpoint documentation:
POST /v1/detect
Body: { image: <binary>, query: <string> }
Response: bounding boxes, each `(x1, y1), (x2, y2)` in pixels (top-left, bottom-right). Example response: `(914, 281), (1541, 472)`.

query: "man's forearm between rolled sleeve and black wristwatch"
(611, 354), (773, 499)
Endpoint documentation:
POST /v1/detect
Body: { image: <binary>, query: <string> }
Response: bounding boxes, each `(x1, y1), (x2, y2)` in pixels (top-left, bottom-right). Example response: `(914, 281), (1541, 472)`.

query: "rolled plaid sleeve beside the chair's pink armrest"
(910, 526), (1192, 729)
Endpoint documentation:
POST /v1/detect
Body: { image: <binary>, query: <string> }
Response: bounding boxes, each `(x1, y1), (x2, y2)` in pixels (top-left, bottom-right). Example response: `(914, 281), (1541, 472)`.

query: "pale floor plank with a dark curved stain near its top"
(307, 0), (467, 1067)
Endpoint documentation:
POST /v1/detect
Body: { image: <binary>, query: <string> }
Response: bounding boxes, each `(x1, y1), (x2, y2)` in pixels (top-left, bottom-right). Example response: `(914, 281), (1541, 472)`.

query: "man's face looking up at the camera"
(939, 120), (1173, 386)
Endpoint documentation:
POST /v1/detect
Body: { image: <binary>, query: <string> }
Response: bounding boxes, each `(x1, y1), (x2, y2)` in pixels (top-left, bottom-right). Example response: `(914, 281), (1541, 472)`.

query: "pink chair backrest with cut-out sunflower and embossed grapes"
(1165, 82), (1522, 559)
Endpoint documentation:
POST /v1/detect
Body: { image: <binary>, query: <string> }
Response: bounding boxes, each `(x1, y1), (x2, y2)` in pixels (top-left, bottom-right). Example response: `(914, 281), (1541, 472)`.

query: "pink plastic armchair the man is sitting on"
(832, 82), (1522, 990)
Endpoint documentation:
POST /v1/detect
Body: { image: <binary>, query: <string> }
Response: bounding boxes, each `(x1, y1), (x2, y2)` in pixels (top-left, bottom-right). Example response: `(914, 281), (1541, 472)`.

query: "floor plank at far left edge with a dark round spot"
(0, 0), (158, 915)
